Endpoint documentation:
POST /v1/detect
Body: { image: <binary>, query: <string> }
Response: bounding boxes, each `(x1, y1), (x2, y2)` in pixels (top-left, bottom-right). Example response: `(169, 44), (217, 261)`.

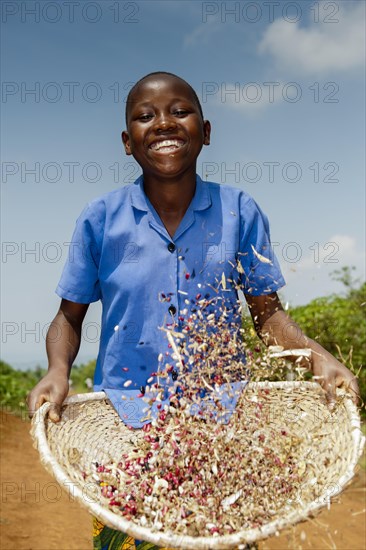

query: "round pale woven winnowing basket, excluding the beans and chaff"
(32, 382), (364, 550)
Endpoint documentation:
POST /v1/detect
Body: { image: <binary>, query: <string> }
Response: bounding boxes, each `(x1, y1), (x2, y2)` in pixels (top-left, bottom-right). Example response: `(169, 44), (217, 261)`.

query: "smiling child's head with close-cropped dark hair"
(122, 74), (210, 178)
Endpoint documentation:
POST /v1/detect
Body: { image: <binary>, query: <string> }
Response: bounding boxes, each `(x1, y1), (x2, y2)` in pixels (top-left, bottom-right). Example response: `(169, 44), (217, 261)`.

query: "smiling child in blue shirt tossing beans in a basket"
(28, 72), (359, 550)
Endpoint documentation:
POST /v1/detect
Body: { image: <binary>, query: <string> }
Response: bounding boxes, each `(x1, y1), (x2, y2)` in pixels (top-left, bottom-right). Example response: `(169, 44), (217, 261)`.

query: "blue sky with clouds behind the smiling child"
(1, 0), (366, 367)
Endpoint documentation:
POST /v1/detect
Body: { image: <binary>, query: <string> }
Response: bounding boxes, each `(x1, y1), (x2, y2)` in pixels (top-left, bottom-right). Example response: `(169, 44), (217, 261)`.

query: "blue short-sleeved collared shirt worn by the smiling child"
(56, 176), (284, 426)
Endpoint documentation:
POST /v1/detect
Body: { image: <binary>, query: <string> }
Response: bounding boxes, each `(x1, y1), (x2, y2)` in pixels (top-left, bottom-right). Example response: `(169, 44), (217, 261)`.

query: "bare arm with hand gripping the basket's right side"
(245, 293), (360, 406)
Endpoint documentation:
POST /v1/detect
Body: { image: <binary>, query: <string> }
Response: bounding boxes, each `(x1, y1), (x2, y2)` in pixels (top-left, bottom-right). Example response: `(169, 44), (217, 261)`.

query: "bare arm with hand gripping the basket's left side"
(27, 300), (89, 422)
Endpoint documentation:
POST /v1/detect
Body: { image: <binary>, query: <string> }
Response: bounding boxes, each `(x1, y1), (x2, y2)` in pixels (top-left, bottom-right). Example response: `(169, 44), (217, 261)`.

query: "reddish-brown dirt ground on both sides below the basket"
(0, 413), (366, 550)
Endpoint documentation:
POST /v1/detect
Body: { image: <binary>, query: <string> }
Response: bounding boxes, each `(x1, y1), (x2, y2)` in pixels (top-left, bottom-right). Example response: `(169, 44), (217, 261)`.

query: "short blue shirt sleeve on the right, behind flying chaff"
(238, 197), (285, 296)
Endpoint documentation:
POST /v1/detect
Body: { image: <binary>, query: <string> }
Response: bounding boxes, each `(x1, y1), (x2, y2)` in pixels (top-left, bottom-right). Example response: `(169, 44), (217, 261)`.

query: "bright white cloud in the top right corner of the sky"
(259, 1), (365, 75)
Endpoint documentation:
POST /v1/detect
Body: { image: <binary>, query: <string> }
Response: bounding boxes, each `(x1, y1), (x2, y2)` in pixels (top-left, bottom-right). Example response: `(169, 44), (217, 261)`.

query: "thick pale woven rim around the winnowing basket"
(31, 381), (365, 550)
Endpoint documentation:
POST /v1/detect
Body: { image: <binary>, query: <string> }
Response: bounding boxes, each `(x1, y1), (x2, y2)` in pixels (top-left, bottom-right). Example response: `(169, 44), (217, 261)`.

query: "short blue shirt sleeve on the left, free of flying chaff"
(56, 205), (103, 304)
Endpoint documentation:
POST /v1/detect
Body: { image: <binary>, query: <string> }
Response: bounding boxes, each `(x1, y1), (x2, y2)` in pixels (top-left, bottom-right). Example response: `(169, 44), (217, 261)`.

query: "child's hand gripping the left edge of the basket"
(27, 371), (69, 422)
